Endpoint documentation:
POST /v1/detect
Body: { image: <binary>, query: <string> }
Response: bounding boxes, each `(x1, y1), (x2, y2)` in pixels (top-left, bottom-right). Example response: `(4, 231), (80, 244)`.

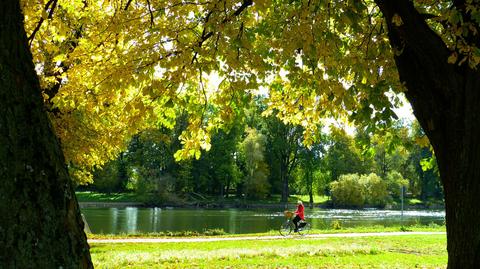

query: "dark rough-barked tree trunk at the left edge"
(0, 0), (93, 268)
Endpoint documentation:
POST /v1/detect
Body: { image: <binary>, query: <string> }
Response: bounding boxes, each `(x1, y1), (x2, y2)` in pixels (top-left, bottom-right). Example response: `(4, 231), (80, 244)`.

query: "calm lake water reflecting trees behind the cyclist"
(82, 207), (445, 234)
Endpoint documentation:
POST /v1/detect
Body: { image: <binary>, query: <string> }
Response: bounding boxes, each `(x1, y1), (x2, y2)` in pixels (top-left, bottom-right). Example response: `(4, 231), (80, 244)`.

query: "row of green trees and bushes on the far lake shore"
(81, 98), (443, 206)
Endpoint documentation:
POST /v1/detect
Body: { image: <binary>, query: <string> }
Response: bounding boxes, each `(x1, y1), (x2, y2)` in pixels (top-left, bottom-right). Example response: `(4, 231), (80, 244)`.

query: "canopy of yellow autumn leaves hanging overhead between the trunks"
(22, 0), (480, 184)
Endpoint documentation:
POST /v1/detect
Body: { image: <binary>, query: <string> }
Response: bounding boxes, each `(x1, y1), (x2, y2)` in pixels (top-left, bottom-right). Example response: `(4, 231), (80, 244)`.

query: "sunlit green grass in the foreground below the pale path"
(91, 232), (447, 268)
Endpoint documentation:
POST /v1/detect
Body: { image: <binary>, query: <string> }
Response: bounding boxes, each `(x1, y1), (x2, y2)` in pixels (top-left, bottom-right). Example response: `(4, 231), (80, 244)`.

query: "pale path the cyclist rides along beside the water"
(88, 232), (445, 243)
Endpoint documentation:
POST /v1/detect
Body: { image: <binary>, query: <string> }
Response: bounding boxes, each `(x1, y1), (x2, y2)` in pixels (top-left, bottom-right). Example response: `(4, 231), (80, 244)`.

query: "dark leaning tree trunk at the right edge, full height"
(376, 0), (480, 269)
